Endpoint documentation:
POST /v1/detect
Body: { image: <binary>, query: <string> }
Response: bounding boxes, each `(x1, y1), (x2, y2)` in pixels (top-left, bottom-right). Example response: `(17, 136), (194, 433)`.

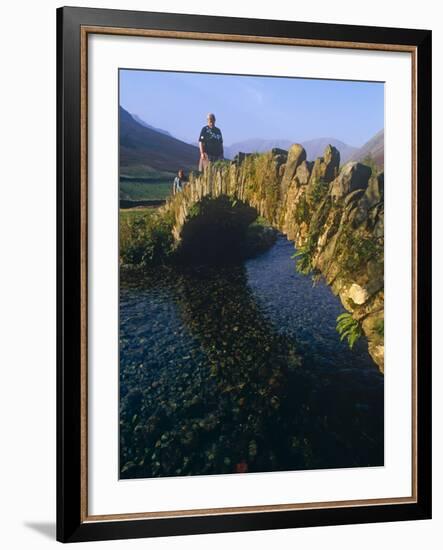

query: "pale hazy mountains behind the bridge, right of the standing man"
(225, 138), (357, 164)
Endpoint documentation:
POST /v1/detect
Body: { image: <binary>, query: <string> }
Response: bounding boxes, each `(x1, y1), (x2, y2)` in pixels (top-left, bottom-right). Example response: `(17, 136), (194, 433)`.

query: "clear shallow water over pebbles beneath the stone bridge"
(120, 237), (384, 478)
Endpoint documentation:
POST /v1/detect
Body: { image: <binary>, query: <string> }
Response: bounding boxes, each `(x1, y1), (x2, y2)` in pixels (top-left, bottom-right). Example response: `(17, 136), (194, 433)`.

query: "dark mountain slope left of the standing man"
(120, 107), (199, 174)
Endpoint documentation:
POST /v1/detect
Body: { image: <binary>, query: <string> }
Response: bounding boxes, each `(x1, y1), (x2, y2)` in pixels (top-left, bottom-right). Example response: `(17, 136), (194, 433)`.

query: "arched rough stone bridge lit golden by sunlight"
(159, 144), (384, 372)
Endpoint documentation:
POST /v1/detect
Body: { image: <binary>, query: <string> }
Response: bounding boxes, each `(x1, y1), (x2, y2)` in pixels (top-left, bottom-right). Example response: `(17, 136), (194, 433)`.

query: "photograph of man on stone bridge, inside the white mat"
(118, 68), (390, 480)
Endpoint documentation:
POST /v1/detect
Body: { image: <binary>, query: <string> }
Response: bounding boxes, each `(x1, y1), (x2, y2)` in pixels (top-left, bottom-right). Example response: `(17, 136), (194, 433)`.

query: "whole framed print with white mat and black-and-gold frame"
(57, 8), (431, 542)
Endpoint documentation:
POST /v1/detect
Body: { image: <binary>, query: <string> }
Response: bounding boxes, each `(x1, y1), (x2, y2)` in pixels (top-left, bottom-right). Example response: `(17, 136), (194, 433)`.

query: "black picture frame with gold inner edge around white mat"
(57, 8), (431, 542)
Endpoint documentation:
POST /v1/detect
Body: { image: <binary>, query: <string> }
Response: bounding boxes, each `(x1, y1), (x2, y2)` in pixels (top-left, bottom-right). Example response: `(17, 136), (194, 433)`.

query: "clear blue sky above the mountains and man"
(120, 69), (384, 147)
